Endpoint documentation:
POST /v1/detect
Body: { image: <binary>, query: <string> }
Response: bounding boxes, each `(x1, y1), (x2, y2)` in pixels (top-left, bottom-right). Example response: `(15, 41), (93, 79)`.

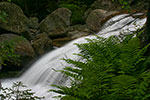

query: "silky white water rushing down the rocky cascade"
(2, 14), (146, 100)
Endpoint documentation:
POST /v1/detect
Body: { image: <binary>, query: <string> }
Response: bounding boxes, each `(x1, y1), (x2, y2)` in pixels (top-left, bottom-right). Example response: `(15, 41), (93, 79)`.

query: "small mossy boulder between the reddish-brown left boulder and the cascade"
(31, 33), (52, 55)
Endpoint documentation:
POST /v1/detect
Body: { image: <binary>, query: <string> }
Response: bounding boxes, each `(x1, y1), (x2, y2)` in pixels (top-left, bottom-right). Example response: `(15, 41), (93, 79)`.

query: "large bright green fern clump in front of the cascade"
(50, 35), (150, 100)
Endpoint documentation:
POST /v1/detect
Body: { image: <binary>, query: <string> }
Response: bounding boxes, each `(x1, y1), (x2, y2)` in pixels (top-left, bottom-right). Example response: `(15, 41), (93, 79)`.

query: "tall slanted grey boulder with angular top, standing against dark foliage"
(39, 8), (71, 37)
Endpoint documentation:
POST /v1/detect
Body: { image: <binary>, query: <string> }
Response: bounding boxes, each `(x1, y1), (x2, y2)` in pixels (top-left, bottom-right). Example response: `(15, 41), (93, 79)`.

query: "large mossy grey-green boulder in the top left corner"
(0, 2), (30, 34)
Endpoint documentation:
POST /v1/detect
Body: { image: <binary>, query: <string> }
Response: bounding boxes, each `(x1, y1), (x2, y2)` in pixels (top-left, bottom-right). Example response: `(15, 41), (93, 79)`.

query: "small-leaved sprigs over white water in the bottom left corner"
(0, 82), (44, 100)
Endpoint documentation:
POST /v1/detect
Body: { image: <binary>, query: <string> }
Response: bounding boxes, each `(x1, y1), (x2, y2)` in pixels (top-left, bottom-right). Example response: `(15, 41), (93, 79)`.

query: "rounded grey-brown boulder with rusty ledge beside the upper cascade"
(86, 9), (118, 32)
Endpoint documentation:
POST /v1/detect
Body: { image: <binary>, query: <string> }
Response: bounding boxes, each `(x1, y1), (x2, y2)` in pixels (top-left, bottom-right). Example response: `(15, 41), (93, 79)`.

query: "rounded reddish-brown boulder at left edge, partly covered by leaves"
(0, 34), (35, 66)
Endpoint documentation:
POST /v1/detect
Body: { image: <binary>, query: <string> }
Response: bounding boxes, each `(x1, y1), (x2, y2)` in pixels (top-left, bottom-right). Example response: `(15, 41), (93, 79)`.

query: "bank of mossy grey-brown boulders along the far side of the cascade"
(0, 0), (148, 72)
